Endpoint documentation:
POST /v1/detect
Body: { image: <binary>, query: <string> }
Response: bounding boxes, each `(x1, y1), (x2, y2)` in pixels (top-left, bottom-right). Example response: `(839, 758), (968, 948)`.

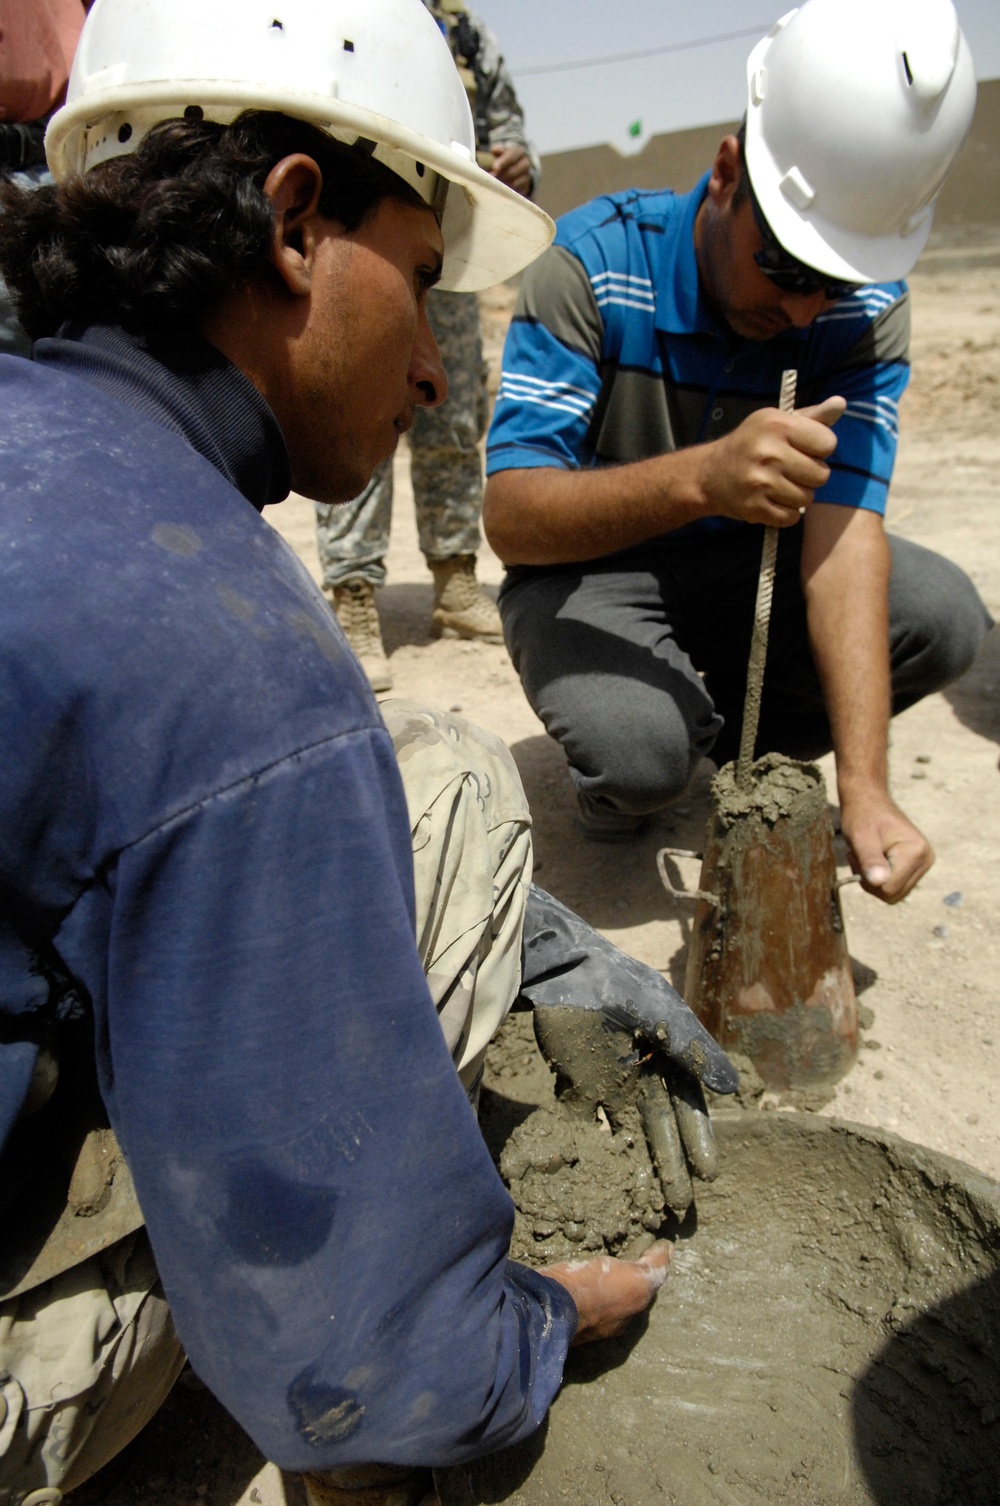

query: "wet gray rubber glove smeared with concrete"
(521, 884), (738, 1214)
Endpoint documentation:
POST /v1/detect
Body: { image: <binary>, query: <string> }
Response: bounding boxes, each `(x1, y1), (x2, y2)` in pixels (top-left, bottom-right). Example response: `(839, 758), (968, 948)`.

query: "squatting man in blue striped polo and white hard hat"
(483, 0), (989, 902)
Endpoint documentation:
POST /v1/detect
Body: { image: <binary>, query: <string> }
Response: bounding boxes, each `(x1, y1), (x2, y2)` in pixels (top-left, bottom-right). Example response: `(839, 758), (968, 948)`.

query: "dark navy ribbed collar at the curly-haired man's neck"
(33, 325), (292, 512)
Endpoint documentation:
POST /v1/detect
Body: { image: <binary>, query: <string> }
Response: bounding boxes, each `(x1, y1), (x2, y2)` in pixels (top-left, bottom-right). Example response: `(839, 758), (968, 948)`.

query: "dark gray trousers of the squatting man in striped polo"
(500, 527), (992, 815)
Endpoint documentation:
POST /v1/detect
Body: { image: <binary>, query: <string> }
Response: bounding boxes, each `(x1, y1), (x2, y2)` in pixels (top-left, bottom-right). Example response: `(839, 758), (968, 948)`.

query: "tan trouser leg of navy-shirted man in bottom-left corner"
(0, 1229), (184, 1506)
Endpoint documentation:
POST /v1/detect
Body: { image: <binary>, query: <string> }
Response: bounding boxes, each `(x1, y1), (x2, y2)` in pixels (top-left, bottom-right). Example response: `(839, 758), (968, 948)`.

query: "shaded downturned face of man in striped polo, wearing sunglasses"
(694, 137), (836, 340)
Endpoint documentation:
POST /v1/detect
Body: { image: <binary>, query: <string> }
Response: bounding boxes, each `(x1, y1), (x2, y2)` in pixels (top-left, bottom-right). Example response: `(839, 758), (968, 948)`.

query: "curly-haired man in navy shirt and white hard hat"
(0, 0), (759, 1506)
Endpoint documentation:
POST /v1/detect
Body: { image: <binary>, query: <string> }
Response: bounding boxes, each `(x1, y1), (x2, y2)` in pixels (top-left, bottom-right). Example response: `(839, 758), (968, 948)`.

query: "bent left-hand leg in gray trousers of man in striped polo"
(500, 568), (720, 839)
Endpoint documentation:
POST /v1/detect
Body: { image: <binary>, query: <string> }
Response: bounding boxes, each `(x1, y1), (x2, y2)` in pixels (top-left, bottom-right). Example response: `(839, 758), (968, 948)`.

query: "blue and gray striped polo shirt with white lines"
(486, 175), (910, 533)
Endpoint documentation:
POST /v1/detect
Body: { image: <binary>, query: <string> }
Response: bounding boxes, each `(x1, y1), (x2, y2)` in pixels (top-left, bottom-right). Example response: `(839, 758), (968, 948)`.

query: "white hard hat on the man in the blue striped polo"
(745, 0), (976, 282)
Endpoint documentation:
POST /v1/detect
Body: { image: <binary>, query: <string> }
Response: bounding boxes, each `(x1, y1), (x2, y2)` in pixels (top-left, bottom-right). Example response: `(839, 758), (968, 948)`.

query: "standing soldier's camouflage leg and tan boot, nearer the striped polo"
(410, 291), (503, 643)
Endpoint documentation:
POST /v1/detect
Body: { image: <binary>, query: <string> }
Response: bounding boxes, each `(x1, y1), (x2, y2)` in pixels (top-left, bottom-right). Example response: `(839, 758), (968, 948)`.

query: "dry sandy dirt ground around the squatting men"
(80, 247), (1000, 1506)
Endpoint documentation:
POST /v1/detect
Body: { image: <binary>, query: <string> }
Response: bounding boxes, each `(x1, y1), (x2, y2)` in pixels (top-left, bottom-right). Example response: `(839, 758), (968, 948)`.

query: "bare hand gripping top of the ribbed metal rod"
(700, 398), (846, 529)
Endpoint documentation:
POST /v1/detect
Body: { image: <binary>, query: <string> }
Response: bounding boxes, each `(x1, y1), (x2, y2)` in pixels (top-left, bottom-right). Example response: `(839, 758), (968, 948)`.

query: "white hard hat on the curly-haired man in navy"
(45, 0), (554, 292)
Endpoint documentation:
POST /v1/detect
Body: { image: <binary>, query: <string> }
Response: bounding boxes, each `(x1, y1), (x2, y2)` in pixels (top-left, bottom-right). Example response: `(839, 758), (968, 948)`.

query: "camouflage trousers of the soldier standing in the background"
(316, 289), (486, 586)
